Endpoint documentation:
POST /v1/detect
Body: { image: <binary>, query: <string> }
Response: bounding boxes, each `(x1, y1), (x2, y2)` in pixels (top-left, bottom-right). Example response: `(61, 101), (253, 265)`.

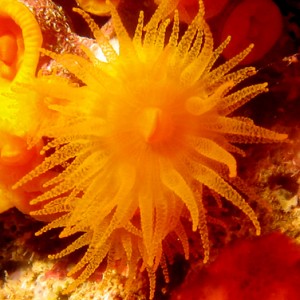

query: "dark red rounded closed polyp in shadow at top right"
(222, 0), (283, 64)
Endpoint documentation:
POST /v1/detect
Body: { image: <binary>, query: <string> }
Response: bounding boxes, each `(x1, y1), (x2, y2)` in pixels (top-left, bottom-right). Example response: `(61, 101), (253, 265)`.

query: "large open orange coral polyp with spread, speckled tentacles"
(14, 1), (286, 299)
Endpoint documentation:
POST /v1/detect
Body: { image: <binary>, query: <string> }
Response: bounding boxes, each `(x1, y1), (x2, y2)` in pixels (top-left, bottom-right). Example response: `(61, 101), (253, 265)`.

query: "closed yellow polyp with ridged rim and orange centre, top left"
(0, 0), (42, 85)
